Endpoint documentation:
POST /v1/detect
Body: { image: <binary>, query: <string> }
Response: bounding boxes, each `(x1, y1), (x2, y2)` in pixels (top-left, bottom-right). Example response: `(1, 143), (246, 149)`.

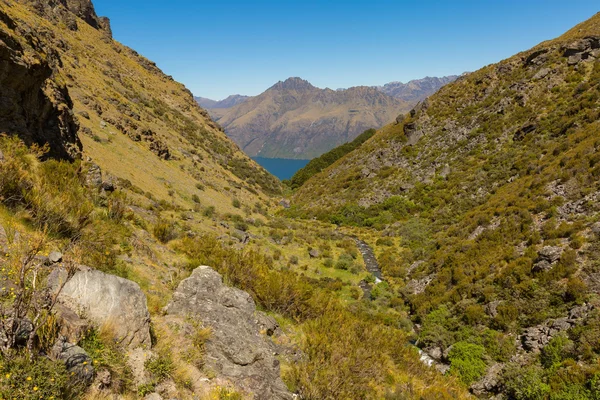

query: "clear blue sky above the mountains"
(93, 0), (600, 100)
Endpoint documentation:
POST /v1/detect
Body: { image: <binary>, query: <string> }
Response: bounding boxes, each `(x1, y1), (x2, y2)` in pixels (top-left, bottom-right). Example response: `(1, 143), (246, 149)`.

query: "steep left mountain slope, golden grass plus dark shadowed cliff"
(0, 0), (279, 212)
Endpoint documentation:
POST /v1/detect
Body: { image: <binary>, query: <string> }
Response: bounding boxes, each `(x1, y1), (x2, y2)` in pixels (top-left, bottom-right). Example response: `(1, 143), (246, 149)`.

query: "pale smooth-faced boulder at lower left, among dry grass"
(49, 267), (151, 347)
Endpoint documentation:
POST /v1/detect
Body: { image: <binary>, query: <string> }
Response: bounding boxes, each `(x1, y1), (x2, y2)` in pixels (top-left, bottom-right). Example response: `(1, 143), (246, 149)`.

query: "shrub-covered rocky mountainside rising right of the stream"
(289, 14), (600, 399)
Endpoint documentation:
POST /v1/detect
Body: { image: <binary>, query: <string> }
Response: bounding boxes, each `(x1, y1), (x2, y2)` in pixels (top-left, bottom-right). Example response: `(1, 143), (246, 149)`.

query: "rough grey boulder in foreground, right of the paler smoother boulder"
(166, 267), (292, 399)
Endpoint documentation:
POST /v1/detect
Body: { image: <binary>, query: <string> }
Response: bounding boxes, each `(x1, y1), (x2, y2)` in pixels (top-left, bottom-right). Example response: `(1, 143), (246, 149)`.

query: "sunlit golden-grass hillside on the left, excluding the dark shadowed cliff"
(0, 3), (279, 216)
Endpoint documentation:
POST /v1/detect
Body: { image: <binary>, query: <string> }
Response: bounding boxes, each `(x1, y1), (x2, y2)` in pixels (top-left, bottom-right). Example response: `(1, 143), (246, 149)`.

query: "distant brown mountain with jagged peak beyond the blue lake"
(217, 78), (410, 159)
